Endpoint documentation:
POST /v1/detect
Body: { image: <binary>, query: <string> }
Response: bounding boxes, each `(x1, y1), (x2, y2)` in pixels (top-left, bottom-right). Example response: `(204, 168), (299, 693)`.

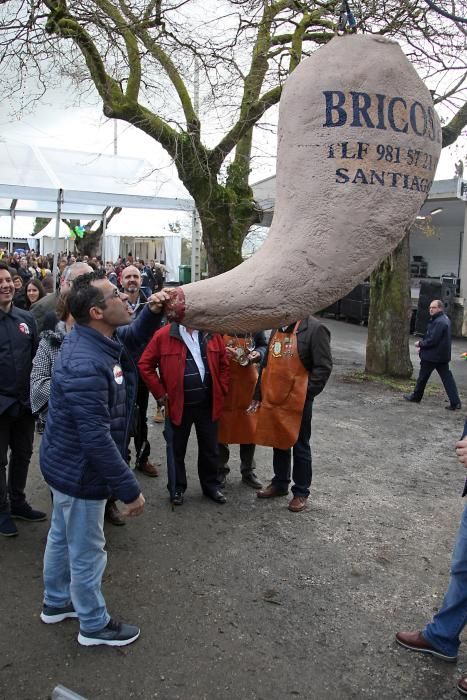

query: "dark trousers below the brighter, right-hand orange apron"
(271, 398), (313, 498)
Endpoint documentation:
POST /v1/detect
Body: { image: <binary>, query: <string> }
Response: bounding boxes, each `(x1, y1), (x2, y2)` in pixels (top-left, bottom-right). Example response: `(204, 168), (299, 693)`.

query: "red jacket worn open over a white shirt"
(138, 323), (229, 425)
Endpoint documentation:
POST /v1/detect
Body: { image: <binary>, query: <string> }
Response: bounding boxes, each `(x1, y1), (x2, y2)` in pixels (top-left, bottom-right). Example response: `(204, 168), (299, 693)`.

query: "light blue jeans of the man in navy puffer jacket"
(44, 489), (110, 632)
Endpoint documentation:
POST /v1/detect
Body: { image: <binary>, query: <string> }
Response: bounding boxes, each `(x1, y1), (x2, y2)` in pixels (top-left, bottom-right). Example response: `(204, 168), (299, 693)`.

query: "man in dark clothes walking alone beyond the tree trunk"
(404, 299), (462, 411)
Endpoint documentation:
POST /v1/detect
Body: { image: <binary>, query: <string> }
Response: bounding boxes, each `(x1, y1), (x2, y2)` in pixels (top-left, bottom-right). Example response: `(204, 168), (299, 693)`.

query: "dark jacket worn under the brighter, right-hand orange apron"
(254, 316), (332, 401)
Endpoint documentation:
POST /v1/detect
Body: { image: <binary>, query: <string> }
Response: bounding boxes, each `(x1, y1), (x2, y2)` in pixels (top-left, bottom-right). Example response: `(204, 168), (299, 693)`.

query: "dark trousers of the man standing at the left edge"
(0, 413), (34, 513)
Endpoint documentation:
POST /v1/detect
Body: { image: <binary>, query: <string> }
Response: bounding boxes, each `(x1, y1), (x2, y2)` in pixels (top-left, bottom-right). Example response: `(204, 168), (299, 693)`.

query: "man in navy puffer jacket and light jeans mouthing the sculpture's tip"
(40, 272), (167, 646)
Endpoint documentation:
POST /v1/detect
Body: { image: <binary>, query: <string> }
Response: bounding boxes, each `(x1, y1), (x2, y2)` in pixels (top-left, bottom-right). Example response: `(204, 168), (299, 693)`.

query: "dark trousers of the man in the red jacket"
(172, 403), (220, 492)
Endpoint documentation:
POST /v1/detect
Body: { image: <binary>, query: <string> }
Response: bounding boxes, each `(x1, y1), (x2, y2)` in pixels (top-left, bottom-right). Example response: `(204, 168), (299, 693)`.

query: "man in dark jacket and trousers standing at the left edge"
(0, 262), (46, 537)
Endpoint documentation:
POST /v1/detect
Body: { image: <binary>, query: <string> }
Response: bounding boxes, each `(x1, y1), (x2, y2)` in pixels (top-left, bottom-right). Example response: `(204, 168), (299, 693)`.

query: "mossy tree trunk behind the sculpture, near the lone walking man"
(365, 234), (413, 379)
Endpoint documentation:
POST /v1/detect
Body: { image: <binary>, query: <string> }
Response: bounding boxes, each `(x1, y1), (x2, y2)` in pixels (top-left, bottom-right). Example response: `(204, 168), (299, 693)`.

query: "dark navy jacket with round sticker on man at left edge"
(0, 304), (38, 415)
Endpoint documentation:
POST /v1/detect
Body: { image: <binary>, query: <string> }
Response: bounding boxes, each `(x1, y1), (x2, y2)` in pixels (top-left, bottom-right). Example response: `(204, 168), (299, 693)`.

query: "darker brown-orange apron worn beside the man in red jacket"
(217, 335), (258, 445)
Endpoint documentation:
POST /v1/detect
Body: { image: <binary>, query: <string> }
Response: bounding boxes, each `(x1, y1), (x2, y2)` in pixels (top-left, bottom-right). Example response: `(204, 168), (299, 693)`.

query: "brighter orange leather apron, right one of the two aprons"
(255, 321), (308, 450)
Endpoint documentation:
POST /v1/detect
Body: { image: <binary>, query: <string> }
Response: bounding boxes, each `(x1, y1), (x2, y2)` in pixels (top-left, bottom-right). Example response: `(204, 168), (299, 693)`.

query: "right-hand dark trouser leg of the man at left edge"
(8, 413), (35, 510)
